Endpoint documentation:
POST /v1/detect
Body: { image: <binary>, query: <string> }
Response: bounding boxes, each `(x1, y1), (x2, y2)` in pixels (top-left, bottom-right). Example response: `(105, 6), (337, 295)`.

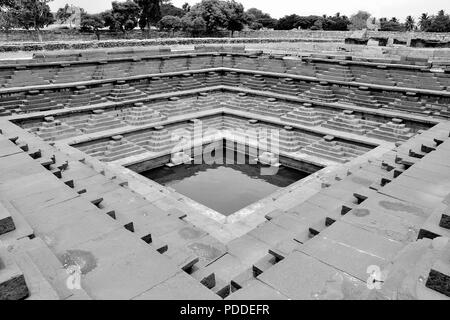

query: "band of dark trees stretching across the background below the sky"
(0, 0), (450, 36)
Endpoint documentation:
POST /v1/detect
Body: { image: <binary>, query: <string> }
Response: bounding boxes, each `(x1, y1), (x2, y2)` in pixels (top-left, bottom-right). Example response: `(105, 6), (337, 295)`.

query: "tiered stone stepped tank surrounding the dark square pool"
(0, 46), (450, 300)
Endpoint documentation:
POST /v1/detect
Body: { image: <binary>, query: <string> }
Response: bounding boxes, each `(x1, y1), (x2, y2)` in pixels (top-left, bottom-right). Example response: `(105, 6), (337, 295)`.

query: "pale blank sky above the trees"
(50, 0), (450, 20)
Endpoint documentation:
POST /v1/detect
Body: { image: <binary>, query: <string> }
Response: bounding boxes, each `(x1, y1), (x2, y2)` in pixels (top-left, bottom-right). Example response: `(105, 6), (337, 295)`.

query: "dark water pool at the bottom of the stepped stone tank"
(141, 154), (309, 216)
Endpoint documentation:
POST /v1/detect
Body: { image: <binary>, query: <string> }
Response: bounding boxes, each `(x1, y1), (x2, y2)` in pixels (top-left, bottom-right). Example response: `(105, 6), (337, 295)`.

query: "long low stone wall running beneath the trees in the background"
(0, 30), (450, 42)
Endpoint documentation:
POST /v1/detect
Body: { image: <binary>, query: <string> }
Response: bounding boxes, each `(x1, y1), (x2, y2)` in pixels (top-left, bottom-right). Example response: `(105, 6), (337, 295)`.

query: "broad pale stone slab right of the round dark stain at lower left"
(60, 229), (180, 300)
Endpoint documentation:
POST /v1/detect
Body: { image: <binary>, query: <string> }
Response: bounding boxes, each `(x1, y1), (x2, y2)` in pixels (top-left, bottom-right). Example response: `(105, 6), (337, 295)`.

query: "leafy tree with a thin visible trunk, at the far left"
(14, 0), (55, 31)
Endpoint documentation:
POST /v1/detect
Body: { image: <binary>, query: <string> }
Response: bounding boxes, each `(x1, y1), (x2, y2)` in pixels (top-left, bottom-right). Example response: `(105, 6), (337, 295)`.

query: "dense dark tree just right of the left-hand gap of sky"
(109, 0), (141, 33)
